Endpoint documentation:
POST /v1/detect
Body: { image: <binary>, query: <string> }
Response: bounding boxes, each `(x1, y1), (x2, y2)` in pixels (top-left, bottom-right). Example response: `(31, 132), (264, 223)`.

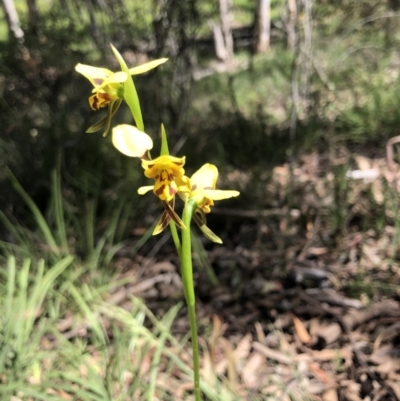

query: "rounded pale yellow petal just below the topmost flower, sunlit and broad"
(112, 124), (153, 157)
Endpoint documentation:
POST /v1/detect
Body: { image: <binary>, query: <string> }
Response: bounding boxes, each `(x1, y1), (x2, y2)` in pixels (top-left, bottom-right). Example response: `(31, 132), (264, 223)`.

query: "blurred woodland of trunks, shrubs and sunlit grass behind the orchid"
(0, 0), (400, 222)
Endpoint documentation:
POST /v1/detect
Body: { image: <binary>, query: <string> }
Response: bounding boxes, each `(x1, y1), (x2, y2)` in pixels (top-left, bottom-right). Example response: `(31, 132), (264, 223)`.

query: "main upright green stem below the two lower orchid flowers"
(180, 200), (201, 401)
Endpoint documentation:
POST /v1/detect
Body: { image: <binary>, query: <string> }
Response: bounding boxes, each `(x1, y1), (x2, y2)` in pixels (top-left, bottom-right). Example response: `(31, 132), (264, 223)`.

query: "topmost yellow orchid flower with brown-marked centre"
(75, 58), (168, 135)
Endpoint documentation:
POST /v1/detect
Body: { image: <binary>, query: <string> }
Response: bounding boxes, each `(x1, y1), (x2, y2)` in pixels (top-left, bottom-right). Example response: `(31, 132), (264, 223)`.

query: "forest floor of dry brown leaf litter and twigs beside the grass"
(97, 148), (400, 401)
